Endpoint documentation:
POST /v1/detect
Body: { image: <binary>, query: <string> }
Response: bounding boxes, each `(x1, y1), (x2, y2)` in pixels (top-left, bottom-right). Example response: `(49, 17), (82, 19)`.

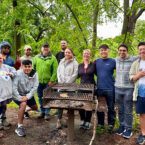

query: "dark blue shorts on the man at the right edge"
(136, 96), (145, 114)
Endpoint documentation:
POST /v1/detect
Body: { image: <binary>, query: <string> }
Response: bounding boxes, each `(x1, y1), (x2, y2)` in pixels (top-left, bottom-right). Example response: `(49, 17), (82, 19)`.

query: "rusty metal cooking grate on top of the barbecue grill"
(44, 84), (94, 101)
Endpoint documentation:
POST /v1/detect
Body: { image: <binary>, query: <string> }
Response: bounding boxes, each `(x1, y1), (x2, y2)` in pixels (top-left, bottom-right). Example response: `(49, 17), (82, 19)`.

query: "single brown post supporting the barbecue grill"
(67, 109), (74, 145)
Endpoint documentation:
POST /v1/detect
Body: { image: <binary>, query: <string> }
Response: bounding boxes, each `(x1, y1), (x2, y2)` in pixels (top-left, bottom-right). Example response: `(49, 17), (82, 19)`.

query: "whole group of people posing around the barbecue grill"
(0, 40), (145, 144)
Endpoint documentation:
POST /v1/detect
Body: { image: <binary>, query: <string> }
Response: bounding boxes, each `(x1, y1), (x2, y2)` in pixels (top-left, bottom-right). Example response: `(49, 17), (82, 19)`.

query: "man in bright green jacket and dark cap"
(33, 43), (58, 120)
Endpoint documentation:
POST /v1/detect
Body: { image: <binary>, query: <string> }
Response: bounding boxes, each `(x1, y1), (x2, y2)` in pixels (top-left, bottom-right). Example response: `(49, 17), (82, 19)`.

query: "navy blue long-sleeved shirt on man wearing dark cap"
(95, 58), (116, 90)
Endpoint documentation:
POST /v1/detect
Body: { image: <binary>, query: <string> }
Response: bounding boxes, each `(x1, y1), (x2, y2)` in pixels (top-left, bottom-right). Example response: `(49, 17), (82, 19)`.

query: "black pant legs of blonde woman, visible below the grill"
(79, 110), (92, 122)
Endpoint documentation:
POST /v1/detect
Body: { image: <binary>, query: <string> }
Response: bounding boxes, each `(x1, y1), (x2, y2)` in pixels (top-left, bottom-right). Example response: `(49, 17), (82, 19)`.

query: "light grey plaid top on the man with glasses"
(115, 56), (138, 88)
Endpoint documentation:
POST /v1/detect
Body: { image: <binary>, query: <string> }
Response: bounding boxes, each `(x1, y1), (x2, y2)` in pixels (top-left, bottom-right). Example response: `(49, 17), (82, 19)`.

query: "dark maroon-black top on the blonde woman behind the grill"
(78, 62), (95, 84)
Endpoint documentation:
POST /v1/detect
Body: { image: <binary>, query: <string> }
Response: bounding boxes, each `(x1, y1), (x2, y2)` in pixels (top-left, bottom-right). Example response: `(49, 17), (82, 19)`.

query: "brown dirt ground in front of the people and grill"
(0, 108), (138, 145)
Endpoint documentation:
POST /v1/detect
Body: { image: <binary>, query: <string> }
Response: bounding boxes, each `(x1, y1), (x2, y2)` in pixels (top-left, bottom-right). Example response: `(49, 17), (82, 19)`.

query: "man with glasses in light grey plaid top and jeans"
(115, 44), (138, 138)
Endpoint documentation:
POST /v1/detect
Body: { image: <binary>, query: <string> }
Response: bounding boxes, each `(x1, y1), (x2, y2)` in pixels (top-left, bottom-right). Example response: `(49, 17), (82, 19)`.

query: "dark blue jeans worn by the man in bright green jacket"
(37, 83), (50, 115)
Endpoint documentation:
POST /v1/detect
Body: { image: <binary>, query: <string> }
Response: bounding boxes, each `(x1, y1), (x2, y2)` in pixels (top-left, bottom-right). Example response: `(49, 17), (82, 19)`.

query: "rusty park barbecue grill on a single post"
(43, 83), (96, 144)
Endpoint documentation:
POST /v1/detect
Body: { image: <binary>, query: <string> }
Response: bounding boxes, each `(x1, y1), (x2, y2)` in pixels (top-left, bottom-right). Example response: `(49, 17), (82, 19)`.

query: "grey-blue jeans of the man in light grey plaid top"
(115, 87), (134, 129)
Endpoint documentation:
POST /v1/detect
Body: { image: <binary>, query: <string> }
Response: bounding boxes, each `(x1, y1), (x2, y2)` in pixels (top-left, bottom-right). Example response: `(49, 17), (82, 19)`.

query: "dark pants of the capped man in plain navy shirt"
(97, 89), (116, 126)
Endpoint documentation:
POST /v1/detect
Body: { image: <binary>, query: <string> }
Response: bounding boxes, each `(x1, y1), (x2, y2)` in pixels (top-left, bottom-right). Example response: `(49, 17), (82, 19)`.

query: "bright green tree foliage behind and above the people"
(0, 0), (145, 62)
